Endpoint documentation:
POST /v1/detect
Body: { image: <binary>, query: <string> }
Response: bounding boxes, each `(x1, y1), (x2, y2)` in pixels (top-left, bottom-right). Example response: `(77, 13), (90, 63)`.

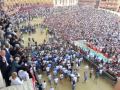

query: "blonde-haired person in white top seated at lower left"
(10, 72), (23, 85)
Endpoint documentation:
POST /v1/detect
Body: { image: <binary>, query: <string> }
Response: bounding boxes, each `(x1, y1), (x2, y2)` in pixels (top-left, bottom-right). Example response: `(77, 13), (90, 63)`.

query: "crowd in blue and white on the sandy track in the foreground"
(29, 33), (100, 90)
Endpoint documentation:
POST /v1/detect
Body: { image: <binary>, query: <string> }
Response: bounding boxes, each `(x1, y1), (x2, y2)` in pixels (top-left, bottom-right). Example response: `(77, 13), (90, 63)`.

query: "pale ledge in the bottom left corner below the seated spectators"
(0, 79), (34, 90)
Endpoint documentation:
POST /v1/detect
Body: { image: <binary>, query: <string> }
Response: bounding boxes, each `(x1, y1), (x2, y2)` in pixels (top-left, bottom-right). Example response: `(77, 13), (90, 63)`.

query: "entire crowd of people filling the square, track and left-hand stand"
(0, 2), (120, 90)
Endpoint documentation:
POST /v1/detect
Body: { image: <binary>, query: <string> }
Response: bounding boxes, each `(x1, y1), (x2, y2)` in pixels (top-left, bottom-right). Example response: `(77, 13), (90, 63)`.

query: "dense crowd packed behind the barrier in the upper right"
(44, 6), (120, 77)
